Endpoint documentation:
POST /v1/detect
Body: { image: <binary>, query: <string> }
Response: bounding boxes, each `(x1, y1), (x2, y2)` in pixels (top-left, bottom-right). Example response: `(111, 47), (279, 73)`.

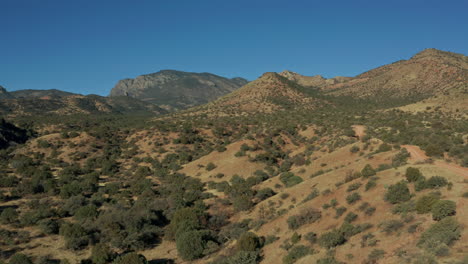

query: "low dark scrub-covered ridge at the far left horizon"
(0, 95), (166, 117)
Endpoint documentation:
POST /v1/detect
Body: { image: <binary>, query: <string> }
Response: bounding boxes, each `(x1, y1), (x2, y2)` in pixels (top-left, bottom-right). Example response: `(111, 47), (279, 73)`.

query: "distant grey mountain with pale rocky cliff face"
(110, 70), (247, 110)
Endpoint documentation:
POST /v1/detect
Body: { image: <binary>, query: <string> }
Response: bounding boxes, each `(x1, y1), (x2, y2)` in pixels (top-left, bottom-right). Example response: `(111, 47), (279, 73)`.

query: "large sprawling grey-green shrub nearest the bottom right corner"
(418, 217), (461, 255)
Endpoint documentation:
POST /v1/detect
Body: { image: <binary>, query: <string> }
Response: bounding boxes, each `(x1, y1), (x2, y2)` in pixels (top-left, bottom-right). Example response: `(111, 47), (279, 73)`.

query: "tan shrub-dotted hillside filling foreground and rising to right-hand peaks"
(0, 50), (468, 264)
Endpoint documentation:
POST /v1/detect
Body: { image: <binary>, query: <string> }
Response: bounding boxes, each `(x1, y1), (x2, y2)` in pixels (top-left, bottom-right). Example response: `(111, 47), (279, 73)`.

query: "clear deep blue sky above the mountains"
(0, 0), (468, 95)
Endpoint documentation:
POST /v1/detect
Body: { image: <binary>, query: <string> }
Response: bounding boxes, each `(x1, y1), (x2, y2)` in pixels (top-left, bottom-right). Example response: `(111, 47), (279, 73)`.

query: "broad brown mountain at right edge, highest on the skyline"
(323, 49), (468, 98)
